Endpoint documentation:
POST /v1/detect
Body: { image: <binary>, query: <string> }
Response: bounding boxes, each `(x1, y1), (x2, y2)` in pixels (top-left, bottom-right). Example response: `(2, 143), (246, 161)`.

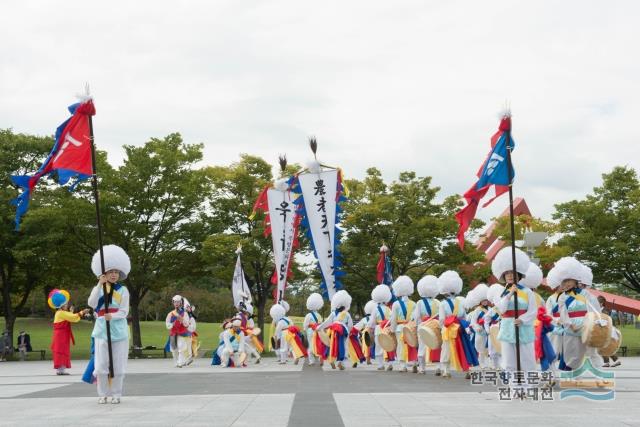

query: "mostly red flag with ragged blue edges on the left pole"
(11, 98), (96, 230)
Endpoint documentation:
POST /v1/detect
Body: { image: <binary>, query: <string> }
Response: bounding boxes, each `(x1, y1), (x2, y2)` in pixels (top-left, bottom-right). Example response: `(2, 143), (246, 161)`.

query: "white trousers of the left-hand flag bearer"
(93, 338), (129, 397)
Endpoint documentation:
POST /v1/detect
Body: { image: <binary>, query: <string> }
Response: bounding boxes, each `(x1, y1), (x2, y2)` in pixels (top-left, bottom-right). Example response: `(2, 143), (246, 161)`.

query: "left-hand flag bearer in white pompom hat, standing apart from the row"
(88, 245), (131, 404)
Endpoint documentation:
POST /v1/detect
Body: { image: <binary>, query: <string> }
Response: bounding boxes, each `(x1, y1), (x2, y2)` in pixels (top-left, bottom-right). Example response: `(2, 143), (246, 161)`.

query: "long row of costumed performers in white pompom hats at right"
(234, 247), (621, 386)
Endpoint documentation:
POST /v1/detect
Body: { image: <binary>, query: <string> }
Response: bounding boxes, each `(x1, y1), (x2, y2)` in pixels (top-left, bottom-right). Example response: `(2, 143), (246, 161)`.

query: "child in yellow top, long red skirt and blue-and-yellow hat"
(47, 289), (88, 375)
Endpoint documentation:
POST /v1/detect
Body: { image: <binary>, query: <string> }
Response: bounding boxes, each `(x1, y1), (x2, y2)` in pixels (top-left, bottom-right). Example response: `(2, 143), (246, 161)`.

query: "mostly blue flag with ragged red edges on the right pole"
(456, 113), (515, 249)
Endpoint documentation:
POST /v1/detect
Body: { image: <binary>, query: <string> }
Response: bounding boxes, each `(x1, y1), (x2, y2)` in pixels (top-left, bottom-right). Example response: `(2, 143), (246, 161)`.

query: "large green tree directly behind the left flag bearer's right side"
(98, 133), (211, 347)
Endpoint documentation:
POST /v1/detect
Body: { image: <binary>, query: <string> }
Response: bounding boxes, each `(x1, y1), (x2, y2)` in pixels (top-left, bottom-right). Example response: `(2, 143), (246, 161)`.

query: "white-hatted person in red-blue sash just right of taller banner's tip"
(318, 290), (353, 370)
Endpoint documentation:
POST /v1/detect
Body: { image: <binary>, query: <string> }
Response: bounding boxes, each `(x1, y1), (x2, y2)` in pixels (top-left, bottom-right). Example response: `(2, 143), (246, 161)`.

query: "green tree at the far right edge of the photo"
(553, 166), (640, 293)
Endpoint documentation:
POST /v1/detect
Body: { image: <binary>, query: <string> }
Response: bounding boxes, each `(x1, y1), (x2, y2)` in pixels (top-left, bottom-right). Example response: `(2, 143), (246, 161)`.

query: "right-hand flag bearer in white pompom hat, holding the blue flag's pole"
(491, 247), (538, 386)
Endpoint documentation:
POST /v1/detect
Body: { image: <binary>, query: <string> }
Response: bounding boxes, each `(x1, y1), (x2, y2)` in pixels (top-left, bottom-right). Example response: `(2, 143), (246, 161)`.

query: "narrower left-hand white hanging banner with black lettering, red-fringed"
(267, 188), (296, 302)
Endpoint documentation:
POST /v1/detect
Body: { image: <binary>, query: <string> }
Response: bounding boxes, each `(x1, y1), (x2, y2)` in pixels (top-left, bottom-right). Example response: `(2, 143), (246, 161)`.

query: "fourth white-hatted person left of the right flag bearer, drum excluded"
(411, 276), (441, 376)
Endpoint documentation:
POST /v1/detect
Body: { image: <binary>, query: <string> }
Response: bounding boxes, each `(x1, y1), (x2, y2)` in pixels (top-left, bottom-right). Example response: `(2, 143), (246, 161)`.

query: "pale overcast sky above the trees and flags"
(0, 0), (640, 227)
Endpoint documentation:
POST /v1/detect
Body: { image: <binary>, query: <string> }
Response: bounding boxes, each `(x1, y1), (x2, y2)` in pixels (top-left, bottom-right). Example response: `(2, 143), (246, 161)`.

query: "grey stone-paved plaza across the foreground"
(0, 358), (640, 427)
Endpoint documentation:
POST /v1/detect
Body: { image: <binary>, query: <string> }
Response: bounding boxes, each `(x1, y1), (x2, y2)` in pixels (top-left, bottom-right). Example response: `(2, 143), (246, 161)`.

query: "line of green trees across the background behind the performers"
(0, 129), (640, 346)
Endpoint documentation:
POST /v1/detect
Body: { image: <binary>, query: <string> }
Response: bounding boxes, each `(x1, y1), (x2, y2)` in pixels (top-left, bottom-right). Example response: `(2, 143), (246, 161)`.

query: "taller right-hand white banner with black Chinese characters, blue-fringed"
(298, 169), (338, 299)
